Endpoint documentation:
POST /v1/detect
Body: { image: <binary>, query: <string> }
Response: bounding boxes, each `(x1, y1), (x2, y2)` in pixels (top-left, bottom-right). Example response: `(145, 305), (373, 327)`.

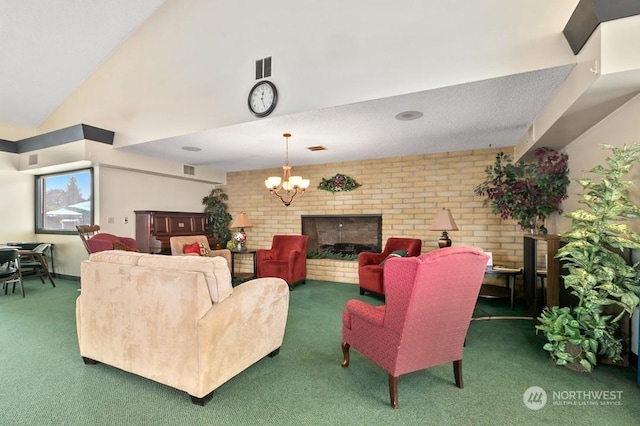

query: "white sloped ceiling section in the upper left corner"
(0, 0), (164, 128)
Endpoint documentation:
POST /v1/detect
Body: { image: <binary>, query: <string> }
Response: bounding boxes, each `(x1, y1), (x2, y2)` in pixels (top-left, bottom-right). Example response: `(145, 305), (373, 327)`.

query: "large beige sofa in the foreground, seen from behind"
(76, 251), (289, 405)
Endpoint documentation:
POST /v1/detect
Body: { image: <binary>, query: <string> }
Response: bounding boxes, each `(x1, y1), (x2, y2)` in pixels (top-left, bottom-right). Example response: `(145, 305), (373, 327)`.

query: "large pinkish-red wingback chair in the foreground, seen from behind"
(342, 246), (488, 408)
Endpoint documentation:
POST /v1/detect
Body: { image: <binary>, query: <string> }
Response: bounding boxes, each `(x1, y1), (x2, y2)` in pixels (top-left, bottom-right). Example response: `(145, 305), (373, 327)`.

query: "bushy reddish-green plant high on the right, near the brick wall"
(473, 147), (569, 233)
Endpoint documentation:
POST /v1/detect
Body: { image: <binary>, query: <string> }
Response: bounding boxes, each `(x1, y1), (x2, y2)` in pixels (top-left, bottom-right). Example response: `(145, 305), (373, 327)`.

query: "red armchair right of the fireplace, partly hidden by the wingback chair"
(358, 237), (422, 294)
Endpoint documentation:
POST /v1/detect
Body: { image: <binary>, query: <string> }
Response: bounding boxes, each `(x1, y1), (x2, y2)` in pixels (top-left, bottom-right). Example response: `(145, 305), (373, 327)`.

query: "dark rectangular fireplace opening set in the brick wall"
(302, 215), (382, 255)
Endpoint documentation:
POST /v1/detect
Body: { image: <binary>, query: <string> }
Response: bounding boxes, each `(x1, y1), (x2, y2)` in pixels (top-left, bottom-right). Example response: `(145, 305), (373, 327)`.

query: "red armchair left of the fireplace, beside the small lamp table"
(256, 235), (309, 289)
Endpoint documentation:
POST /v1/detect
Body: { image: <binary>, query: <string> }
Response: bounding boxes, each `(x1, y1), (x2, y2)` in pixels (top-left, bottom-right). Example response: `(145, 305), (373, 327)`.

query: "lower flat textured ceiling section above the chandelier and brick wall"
(122, 65), (573, 172)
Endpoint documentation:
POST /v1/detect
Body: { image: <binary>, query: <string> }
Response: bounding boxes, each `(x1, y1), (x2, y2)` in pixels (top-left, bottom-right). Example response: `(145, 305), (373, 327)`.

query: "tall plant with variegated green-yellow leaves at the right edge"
(536, 143), (640, 371)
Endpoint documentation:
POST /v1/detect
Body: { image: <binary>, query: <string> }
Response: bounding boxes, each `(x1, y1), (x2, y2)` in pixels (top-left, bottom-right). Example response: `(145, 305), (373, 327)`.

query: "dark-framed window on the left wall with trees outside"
(36, 169), (93, 234)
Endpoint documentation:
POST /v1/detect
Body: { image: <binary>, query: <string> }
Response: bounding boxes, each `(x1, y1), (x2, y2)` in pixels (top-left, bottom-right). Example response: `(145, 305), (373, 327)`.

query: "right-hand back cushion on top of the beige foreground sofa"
(138, 254), (233, 303)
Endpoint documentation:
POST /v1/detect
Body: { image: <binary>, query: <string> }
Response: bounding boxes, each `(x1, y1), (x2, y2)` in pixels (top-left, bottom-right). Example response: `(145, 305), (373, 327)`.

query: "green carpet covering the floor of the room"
(0, 279), (640, 425)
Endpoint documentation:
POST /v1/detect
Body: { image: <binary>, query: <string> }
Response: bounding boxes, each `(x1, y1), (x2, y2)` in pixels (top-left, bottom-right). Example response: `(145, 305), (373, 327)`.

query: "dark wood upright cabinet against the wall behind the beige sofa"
(135, 210), (215, 254)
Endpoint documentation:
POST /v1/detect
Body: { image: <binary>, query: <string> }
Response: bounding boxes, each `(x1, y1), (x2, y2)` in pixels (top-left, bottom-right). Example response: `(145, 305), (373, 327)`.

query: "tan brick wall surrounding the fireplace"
(220, 149), (522, 283)
